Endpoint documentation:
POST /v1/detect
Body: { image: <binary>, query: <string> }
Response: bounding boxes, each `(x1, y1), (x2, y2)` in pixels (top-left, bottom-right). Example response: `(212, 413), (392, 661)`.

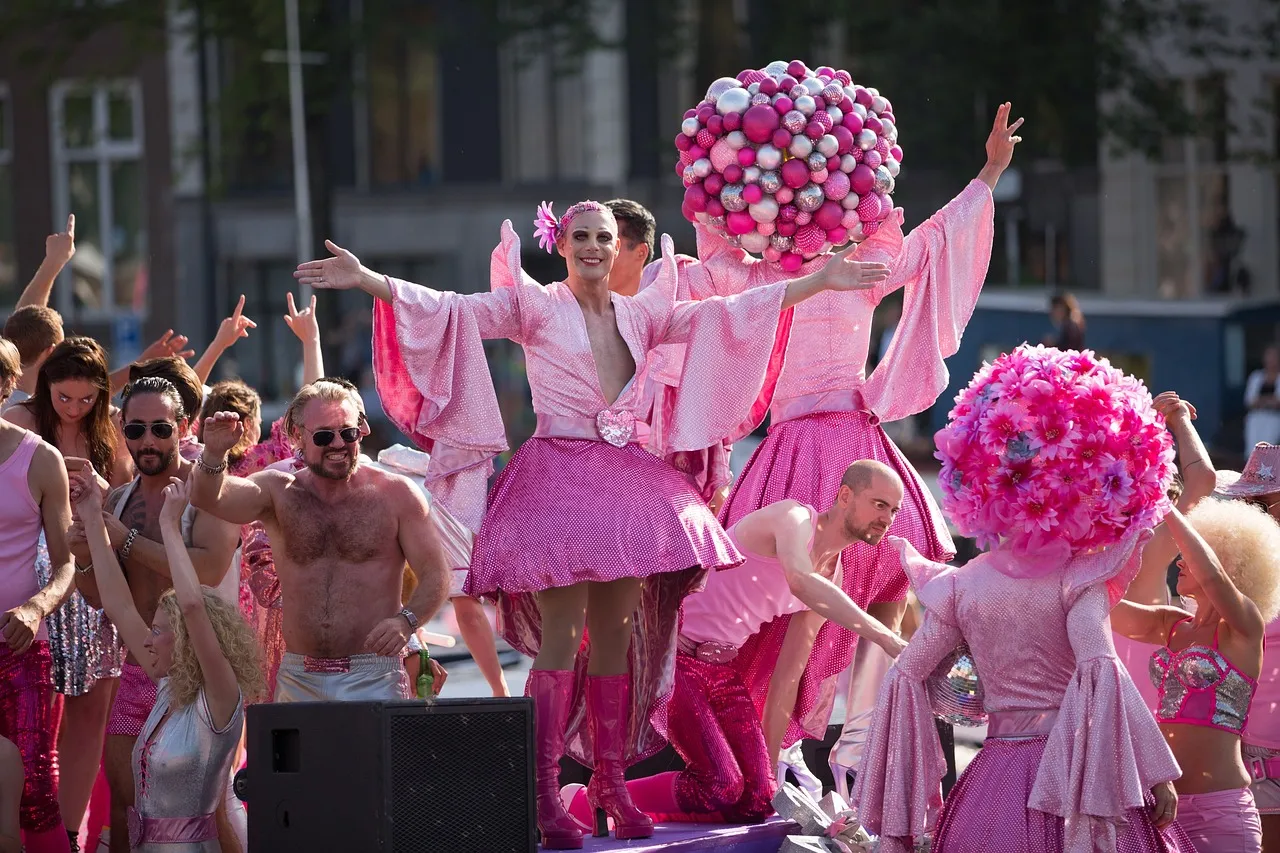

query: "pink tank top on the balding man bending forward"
(680, 505), (818, 648)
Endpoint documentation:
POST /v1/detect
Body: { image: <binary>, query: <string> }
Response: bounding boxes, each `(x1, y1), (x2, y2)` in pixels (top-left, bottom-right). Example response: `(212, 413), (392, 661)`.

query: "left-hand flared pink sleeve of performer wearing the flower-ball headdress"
(851, 574), (964, 853)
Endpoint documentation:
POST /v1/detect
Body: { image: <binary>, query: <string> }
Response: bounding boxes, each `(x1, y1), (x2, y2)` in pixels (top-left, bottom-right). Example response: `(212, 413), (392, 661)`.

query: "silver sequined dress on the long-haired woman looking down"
(36, 533), (124, 695)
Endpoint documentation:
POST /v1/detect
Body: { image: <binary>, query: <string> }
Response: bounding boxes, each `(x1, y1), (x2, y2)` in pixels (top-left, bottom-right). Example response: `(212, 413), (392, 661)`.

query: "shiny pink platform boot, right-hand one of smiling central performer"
(586, 675), (653, 840)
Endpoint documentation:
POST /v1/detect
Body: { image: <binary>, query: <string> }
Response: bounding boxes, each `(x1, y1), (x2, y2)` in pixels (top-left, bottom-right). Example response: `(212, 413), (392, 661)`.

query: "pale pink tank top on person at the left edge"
(0, 432), (49, 639)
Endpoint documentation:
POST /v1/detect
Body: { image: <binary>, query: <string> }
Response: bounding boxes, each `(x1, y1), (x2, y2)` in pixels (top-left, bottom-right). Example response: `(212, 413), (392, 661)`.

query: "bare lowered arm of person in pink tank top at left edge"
(0, 442), (73, 654)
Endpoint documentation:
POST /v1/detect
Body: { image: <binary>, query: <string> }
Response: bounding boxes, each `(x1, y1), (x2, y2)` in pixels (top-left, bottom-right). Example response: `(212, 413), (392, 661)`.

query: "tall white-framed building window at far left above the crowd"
(50, 81), (148, 319)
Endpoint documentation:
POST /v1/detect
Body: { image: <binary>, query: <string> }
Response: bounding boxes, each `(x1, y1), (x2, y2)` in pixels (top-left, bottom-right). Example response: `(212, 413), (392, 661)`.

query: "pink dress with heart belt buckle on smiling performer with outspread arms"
(374, 223), (786, 766)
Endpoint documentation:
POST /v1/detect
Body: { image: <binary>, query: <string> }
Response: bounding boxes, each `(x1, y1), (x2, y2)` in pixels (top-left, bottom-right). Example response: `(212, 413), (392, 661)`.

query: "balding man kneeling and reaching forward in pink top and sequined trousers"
(562, 460), (906, 826)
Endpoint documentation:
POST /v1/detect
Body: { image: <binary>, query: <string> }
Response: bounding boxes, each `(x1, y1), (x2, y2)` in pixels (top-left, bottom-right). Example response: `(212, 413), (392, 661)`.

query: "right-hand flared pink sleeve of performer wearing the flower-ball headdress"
(1027, 583), (1181, 853)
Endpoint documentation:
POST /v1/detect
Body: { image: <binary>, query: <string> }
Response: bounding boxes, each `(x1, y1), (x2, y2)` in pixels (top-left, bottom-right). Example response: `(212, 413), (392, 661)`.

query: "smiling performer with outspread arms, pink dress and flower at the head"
(296, 202), (887, 849)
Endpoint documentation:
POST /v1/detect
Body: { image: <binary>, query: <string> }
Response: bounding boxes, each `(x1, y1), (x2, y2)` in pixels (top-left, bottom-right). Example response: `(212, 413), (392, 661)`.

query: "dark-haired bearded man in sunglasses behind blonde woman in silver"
(72, 377), (239, 853)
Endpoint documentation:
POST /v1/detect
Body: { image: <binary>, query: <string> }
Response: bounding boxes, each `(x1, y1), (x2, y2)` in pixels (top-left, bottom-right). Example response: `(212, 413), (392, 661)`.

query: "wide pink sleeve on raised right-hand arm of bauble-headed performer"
(855, 181), (995, 421)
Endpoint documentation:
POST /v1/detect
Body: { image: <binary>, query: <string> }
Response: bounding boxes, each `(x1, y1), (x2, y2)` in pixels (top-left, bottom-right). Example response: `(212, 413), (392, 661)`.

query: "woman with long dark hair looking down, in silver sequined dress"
(4, 337), (132, 848)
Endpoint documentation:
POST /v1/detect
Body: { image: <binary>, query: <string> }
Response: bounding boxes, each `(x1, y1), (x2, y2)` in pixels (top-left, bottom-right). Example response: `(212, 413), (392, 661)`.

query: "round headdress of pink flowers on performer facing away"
(934, 345), (1174, 553)
